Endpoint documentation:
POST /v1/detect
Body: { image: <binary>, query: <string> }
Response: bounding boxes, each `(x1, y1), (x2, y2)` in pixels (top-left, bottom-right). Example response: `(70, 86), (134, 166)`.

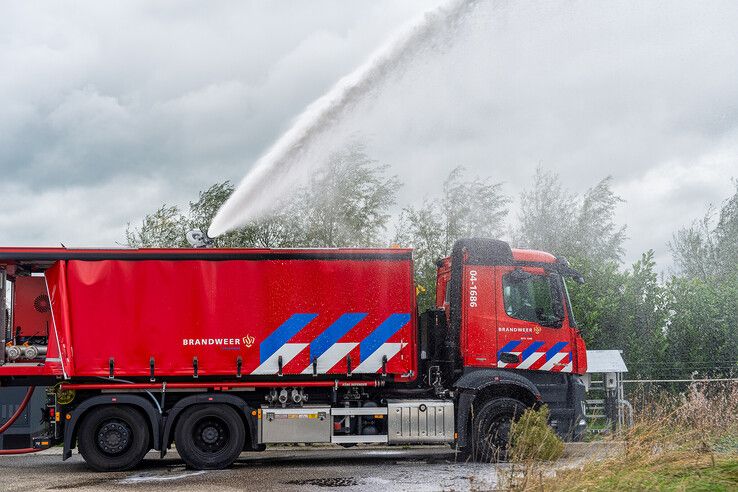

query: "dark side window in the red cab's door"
(502, 270), (564, 327)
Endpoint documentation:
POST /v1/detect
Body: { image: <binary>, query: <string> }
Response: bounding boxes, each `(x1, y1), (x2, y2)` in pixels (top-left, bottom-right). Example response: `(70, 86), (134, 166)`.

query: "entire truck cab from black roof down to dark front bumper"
(421, 239), (587, 458)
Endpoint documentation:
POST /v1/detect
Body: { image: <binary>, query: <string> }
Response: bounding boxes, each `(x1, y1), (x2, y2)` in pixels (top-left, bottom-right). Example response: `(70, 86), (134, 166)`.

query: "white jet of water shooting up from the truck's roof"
(207, 0), (475, 238)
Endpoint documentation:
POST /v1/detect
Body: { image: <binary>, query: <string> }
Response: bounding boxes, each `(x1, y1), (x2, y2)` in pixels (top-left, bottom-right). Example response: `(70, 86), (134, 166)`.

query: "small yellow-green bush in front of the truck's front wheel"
(510, 405), (564, 461)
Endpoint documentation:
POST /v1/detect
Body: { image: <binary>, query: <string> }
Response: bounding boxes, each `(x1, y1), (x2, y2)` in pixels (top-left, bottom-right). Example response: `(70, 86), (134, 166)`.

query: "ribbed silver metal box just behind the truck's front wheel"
(387, 400), (454, 444)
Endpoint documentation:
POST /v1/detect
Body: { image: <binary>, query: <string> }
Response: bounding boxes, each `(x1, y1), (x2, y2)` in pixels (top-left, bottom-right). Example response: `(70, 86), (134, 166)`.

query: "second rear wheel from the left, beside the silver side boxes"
(174, 404), (246, 470)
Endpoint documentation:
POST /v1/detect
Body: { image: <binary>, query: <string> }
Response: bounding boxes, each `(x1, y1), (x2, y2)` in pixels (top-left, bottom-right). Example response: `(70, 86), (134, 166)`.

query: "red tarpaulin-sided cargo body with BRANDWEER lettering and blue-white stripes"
(3, 249), (417, 380)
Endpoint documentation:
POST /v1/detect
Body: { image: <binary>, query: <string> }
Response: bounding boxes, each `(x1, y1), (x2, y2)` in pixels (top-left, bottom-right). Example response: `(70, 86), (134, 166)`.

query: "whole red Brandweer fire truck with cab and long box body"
(0, 239), (586, 470)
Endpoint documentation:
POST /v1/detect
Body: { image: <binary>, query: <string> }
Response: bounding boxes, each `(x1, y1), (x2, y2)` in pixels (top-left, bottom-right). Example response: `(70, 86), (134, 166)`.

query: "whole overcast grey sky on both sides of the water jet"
(0, 0), (738, 270)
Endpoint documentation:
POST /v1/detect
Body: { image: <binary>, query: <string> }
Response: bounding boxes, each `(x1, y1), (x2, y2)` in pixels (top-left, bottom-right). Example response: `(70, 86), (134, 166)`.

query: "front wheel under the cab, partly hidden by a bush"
(472, 398), (527, 463)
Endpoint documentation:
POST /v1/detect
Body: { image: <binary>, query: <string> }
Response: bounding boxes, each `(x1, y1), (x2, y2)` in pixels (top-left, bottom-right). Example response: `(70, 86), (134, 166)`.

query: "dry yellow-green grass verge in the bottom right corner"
(502, 384), (738, 491)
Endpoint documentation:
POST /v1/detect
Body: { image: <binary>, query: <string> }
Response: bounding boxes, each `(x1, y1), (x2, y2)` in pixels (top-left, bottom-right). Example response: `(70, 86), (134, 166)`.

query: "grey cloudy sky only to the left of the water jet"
(0, 1), (423, 245)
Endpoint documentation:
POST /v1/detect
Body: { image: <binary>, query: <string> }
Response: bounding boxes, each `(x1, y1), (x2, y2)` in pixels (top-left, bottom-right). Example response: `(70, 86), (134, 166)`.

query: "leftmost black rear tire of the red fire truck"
(77, 405), (151, 471)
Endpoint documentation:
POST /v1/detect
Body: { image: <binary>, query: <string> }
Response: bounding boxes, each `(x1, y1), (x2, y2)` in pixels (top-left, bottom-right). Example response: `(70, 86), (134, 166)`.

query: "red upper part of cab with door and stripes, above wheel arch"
(436, 240), (587, 374)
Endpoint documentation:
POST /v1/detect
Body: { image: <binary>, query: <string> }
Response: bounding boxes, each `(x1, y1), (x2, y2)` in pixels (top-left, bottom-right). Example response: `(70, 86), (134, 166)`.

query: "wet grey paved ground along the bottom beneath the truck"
(0, 447), (497, 492)
